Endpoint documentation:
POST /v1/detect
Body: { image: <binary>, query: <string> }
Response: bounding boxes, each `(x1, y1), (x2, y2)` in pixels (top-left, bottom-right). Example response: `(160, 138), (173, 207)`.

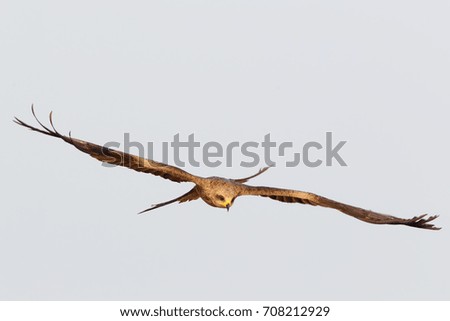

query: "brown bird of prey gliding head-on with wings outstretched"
(14, 106), (440, 230)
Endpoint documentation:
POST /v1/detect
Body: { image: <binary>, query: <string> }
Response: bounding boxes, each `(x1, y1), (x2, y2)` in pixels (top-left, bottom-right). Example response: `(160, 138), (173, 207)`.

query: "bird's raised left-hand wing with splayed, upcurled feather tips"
(14, 106), (201, 183)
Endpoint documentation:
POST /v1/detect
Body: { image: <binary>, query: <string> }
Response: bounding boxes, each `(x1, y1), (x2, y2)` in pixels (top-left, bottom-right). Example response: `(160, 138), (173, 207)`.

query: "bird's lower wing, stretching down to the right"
(239, 185), (440, 230)
